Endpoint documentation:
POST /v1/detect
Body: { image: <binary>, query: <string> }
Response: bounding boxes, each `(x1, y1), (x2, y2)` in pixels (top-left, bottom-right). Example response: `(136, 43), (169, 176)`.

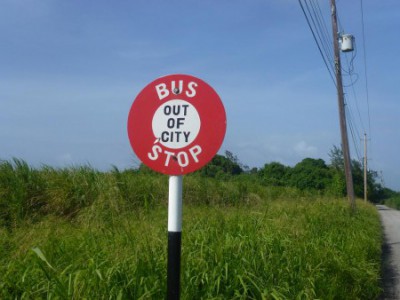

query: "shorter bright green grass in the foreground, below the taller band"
(0, 200), (380, 299)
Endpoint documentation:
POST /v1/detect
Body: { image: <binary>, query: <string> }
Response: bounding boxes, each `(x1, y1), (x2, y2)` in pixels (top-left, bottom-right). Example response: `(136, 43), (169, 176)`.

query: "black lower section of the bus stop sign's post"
(167, 231), (182, 300)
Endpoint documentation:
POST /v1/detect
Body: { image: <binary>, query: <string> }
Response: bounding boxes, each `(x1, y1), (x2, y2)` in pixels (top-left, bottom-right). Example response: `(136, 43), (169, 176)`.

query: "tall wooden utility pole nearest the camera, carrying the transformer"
(330, 0), (356, 212)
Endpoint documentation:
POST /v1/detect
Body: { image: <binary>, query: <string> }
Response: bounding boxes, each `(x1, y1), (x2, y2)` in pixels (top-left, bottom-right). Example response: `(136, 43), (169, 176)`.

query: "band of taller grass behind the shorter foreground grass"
(0, 159), (315, 230)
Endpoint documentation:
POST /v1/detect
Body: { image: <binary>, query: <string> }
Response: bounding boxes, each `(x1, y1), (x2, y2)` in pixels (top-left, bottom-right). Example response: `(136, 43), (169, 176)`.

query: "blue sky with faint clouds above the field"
(0, 0), (400, 190)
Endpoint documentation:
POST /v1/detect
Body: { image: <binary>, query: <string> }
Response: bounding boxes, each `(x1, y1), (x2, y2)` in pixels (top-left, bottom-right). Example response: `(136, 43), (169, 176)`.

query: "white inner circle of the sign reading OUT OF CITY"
(152, 99), (201, 149)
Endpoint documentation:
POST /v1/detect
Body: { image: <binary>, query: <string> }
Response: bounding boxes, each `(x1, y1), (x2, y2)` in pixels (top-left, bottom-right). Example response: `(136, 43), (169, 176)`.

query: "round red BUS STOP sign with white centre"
(128, 74), (226, 175)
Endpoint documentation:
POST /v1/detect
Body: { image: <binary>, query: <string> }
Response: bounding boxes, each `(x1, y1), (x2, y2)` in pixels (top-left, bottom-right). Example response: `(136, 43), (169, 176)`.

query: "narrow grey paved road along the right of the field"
(377, 205), (400, 300)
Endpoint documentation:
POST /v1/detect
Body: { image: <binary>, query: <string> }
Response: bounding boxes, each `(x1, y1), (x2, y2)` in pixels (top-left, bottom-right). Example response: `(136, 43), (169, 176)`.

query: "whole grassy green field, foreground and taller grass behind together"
(0, 161), (382, 299)
